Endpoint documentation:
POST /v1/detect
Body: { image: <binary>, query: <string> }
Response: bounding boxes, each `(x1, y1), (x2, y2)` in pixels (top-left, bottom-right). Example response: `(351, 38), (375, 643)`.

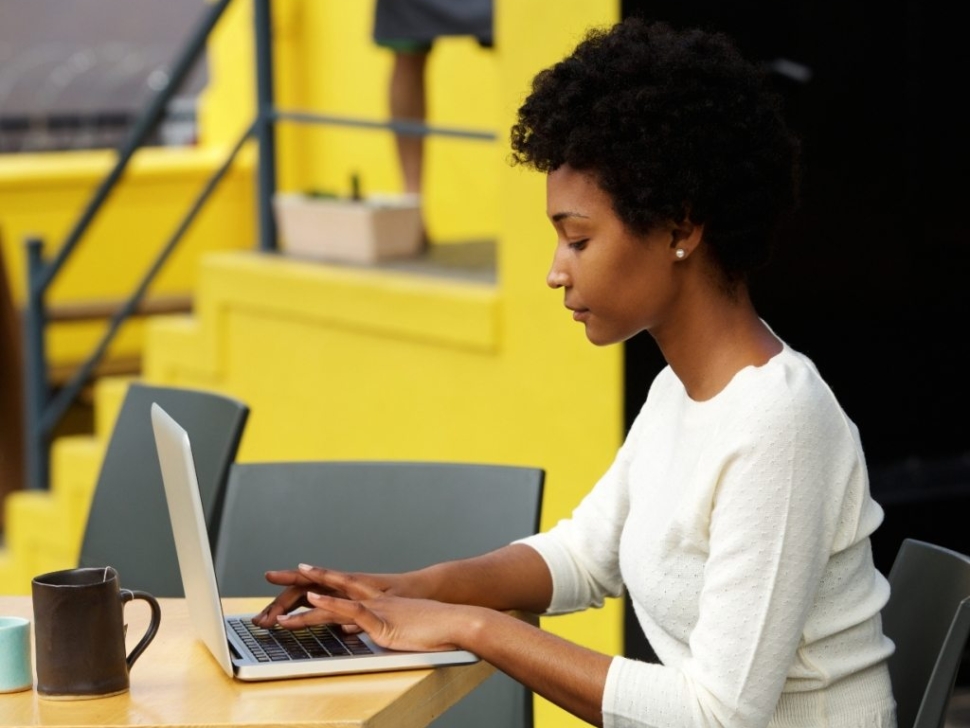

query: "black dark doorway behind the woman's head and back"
(622, 0), (970, 656)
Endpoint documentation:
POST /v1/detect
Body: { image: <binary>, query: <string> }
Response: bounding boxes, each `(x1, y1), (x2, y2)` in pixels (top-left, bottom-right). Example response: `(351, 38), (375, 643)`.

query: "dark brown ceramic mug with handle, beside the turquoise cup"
(31, 566), (162, 700)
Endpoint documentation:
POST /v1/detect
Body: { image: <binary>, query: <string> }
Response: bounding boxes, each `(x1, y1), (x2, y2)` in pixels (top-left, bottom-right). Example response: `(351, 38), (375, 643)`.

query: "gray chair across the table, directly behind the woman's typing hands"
(215, 461), (545, 728)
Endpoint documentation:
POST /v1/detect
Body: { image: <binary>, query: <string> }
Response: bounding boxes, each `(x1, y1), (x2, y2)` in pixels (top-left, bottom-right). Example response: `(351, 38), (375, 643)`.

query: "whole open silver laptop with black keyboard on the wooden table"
(151, 403), (478, 680)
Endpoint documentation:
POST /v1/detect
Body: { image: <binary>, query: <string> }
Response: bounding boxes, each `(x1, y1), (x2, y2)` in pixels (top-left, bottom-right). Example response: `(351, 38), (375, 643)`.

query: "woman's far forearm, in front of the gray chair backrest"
(408, 544), (552, 614)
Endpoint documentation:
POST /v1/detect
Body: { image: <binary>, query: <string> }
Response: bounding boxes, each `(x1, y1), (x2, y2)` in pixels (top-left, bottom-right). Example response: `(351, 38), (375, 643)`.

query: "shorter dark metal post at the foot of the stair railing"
(24, 238), (50, 490)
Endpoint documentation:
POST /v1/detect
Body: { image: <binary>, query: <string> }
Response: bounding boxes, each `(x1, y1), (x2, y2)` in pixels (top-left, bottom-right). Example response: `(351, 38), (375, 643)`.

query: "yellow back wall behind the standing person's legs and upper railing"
(200, 0), (507, 243)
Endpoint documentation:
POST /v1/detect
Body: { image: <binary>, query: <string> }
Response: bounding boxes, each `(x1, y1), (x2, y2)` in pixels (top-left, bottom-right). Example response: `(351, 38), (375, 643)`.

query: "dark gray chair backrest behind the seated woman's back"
(882, 539), (970, 728)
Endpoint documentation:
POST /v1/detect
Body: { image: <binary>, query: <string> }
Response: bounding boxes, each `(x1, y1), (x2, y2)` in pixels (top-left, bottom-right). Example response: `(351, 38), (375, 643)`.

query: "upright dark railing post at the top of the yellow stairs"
(253, 0), (276, 250)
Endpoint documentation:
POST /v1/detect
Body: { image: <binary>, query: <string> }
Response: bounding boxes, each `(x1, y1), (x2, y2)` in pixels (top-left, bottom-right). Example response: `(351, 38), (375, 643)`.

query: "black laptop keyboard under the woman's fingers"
(227, 617), (372, 662)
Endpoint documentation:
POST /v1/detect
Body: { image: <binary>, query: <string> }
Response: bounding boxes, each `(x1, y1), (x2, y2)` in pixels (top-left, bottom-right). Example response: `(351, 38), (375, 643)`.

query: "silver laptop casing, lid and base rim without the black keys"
(151, 403), (478, 680)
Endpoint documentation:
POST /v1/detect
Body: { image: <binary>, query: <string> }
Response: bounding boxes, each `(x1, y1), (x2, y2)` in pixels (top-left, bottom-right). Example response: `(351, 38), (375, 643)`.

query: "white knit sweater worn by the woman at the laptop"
(523, 346), (896, 728)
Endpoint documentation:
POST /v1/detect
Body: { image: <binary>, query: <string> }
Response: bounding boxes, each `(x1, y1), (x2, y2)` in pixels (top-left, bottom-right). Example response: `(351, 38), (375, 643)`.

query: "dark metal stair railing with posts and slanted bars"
(23, 0), (496, 490)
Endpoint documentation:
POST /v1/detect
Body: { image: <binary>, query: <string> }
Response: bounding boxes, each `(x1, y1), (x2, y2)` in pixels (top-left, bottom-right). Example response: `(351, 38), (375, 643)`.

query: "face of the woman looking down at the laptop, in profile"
(546, 166), (680, 346)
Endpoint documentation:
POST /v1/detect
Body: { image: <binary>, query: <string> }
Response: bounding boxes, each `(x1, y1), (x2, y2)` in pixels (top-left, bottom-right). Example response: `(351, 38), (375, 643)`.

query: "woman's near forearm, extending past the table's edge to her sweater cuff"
(455, 609), (612, 726)
